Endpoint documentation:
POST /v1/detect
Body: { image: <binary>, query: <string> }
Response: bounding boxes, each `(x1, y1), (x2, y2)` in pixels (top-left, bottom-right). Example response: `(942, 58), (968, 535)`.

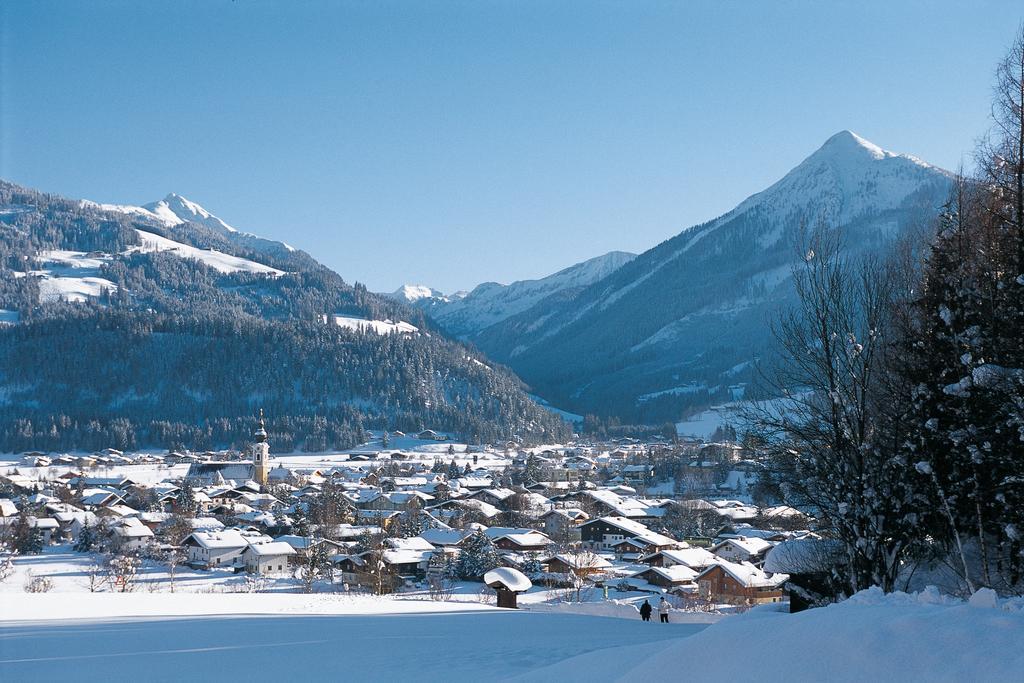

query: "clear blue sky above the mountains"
(0, 0), (1024, 291)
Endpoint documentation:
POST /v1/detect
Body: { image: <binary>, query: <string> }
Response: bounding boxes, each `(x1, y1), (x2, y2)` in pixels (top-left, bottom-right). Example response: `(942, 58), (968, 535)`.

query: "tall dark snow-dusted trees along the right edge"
(757, 31), (1024, 594)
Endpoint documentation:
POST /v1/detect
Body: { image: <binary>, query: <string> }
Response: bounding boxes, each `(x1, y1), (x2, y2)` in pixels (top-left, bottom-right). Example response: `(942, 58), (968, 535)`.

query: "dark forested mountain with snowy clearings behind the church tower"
(0, 181), (567, 452)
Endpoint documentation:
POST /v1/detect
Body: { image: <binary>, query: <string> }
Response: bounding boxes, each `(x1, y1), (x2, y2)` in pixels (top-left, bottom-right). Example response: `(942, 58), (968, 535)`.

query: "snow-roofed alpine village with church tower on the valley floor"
(0, 417), (824, 616)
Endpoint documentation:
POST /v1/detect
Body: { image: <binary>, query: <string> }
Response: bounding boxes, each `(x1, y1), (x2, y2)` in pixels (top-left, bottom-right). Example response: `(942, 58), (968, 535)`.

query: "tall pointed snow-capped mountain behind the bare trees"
(473, 131), (950, 421)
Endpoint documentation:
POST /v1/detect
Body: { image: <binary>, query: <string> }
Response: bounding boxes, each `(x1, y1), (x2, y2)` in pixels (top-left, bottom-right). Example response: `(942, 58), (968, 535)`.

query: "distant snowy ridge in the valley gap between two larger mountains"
(391, 251), (636, 339)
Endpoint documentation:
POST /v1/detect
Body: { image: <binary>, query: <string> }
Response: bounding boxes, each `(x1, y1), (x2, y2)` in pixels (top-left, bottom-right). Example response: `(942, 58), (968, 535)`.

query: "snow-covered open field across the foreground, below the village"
(0, 547), (1024, 683)
